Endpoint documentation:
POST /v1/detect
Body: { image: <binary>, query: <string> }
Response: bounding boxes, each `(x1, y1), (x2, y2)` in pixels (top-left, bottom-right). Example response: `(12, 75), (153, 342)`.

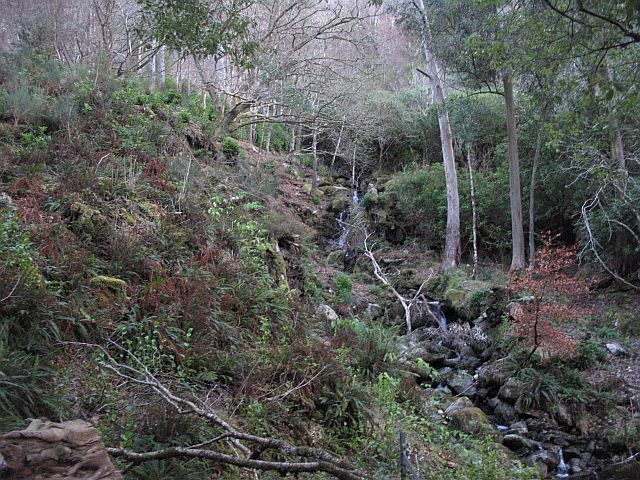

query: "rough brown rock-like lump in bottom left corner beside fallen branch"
(0, 420), (123, 480)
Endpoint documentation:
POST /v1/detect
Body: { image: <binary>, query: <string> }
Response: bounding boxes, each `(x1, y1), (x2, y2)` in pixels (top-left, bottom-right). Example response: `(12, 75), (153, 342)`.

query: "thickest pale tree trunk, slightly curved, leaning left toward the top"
(415, 0), (460, 270)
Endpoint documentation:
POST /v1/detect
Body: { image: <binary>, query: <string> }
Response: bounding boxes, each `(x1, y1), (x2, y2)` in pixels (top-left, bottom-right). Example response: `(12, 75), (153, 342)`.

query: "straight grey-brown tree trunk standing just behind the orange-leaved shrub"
(502, 75), (525, 270)
